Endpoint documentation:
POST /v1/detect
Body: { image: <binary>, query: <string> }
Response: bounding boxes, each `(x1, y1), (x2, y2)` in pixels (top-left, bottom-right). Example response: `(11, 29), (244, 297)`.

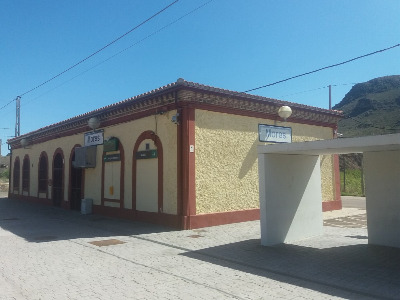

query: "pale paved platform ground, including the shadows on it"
(0, 199), (400, 300)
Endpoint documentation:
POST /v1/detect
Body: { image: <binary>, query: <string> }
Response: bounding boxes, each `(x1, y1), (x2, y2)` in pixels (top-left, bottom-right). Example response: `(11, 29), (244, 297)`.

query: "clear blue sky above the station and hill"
(0, 0), (400, 155)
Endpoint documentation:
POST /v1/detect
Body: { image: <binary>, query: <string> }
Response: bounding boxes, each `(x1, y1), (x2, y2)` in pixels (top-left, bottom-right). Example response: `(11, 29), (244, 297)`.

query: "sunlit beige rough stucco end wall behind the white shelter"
(195, 110), (334, 214)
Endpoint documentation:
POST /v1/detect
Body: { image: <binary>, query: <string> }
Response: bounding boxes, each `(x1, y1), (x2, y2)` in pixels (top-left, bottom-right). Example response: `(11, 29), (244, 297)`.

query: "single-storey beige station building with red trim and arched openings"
(8, 79), (342, 229)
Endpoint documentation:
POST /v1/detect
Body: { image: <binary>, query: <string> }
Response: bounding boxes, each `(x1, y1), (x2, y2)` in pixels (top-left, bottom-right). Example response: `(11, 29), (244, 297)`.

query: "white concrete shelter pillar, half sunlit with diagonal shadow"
(258, 154), (323, 246)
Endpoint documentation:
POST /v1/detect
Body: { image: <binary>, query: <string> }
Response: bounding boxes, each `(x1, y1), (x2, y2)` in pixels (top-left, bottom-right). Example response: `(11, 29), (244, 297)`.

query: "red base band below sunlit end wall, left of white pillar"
(186, 208), (260, 229)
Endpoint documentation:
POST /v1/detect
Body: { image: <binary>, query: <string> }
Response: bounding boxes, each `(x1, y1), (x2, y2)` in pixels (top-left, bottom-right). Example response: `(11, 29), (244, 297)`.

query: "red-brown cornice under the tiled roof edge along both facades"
(10, 87), (341, 149)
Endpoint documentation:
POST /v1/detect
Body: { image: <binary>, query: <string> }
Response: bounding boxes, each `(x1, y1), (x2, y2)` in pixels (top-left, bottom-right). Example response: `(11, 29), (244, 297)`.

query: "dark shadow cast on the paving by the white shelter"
(181, 239), (400, 299)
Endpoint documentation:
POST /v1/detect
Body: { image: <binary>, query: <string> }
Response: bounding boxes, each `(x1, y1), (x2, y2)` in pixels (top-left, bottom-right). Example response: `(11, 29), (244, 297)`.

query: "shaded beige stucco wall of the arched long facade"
(10, 111), (178, 214)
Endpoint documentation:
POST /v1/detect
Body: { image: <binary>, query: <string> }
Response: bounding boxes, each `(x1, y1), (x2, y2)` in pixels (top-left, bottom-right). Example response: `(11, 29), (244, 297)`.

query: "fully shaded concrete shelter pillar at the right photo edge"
(363, 150), (400, 247)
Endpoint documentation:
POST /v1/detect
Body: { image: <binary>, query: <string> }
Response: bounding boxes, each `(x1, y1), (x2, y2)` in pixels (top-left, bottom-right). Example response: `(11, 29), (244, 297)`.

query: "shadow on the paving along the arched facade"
(0, 198), (174, 243)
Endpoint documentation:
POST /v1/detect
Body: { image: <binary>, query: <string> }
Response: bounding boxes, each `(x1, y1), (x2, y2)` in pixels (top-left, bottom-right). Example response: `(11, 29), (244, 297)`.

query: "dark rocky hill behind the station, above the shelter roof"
(333, 75), (400, 137)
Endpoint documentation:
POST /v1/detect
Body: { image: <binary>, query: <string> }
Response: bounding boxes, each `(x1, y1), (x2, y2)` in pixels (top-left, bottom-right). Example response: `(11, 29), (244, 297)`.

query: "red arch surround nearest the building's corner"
(132, 130), (164, 213)
